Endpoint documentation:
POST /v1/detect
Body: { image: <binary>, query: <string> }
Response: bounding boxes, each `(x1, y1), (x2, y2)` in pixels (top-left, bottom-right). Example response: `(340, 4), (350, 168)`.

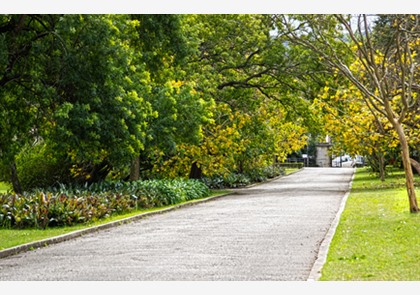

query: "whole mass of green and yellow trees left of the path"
(0, 14), (328, 190)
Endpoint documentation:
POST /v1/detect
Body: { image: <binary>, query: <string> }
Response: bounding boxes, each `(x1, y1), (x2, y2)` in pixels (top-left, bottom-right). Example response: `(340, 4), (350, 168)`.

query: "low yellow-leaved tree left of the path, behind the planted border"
(154, 95), (307, 177)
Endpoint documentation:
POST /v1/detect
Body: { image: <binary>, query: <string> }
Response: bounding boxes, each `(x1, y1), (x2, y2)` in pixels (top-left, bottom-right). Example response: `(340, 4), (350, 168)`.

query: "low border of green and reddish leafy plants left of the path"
(0, 180), (210, 228)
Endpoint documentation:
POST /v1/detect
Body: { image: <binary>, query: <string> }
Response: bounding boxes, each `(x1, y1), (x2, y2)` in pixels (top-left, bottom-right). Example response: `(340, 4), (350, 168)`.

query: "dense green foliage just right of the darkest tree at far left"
(48, 15), (152, 171)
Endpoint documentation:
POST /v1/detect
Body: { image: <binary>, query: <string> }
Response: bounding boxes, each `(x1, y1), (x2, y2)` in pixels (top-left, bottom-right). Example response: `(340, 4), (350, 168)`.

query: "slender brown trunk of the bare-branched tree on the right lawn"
(393, 121), (420, 213)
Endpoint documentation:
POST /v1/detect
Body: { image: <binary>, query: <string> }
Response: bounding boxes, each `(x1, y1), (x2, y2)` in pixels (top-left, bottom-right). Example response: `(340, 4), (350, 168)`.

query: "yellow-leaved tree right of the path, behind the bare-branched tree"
(313, 80), (398, 181)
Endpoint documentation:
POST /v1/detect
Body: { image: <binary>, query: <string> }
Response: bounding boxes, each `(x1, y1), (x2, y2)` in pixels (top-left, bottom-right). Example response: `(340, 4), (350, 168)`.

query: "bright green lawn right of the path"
(320, 168), (420, 281)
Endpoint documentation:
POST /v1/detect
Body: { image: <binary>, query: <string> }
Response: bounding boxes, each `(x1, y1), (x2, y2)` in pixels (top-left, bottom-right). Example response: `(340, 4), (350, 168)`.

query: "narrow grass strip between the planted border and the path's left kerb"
(0, 190), (228, 250)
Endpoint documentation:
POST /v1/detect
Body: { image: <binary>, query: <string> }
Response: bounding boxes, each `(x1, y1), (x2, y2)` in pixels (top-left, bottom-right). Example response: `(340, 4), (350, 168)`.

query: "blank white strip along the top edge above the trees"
(0, 0), (420, 14)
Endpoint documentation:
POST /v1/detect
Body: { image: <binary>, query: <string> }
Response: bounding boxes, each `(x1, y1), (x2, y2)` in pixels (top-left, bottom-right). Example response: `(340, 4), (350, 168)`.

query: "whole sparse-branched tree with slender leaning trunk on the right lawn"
(277, 15), (420, 213)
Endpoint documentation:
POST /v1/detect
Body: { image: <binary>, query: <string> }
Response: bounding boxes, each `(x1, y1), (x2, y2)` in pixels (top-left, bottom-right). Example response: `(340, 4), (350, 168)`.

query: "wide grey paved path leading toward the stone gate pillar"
(0, 168), (354, 281)
